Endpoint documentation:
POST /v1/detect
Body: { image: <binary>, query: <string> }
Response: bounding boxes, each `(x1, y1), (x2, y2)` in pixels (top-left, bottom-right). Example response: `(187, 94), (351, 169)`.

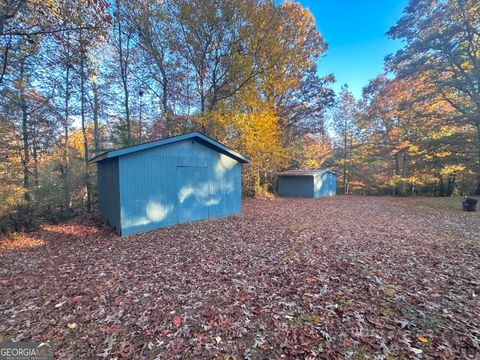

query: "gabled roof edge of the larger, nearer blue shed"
(90, 131), (250, 163)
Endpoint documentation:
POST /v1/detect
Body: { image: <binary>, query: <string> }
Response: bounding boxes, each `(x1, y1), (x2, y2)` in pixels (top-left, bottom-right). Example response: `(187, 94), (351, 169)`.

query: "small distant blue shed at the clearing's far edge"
(277, 170), (337, 198)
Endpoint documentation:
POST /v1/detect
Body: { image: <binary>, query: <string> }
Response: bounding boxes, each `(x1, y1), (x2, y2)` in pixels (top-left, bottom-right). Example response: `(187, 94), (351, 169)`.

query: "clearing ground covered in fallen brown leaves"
(0, 196), (480, 359)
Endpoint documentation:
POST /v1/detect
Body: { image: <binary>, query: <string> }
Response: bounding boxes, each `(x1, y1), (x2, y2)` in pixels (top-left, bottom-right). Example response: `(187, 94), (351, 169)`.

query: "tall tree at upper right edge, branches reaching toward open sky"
(386, 0), (480, 194)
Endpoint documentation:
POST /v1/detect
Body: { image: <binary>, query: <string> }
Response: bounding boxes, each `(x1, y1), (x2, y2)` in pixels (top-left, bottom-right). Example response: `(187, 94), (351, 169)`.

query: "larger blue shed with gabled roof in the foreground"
(90, 132), (250, 236)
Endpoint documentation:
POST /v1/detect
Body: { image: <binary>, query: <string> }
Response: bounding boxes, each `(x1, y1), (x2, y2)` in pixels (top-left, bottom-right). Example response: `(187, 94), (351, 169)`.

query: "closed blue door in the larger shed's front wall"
(177, 166), (210, 223)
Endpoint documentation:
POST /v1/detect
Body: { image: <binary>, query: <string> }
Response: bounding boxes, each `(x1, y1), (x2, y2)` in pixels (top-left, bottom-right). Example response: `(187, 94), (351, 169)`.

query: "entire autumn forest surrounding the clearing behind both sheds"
(0, 0), (480, 230)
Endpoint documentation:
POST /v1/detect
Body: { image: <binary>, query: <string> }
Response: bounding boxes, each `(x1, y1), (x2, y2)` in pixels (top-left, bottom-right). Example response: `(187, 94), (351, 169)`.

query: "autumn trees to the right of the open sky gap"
(333, 0), (480, 196)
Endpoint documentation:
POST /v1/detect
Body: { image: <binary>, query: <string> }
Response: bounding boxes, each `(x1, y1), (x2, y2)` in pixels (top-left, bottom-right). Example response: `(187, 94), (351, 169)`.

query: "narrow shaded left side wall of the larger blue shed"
(97, 158), (120, 231)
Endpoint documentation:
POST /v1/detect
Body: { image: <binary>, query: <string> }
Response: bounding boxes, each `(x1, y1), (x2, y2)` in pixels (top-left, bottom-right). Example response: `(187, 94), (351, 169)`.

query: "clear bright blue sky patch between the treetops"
(300, 0), (407, 97)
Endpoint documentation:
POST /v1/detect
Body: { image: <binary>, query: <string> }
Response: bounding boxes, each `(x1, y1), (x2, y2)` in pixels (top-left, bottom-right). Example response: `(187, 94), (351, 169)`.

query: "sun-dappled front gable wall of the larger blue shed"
(118, 139), (242, 235)
